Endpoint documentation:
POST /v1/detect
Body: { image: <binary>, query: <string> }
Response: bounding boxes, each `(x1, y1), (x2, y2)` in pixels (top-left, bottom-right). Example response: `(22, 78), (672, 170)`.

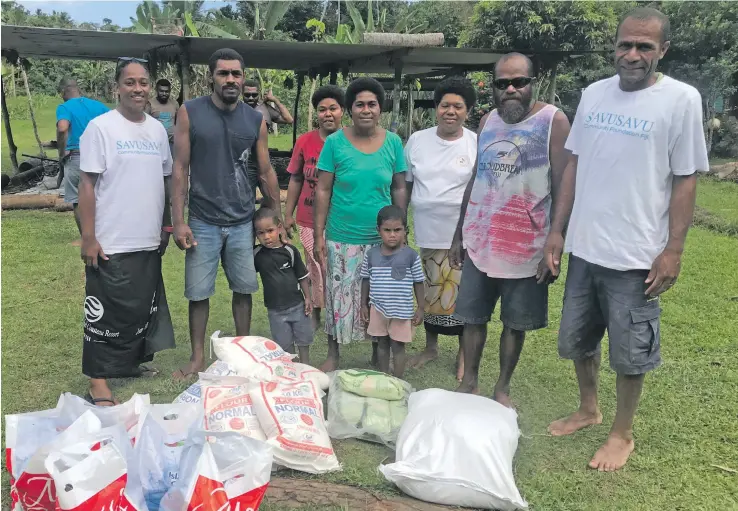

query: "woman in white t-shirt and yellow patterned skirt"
(405, 77), (477, 381)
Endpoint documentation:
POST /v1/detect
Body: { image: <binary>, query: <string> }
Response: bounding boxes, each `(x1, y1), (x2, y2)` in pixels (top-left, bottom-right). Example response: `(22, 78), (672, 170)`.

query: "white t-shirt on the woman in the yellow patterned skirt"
(405, 127), (477, 249)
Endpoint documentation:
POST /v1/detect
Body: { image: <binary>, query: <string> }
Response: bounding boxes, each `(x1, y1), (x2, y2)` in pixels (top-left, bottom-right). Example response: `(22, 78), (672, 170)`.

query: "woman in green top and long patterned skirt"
(314, 78), (407, 371)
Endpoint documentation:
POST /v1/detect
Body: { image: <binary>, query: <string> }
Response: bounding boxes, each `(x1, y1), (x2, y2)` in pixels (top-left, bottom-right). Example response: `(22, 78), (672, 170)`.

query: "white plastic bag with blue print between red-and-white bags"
(130, 403), (202, 511)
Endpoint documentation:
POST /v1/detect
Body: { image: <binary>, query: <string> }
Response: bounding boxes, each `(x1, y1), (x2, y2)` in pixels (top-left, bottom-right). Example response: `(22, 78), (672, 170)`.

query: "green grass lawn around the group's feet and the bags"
(2, 206), (738, 511)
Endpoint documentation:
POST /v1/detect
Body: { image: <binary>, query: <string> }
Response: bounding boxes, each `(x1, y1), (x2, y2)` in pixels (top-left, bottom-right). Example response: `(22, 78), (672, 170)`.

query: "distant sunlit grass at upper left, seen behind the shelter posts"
(2, 96), (292, 174)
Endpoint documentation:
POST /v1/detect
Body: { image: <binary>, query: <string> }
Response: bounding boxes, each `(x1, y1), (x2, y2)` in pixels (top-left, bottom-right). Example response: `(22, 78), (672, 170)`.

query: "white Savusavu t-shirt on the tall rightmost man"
(565, 76), (709, 271)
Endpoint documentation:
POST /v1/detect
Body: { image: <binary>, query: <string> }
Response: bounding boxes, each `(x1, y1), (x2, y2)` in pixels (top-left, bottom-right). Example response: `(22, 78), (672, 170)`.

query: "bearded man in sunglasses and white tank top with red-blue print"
(449, 53), (569, 407)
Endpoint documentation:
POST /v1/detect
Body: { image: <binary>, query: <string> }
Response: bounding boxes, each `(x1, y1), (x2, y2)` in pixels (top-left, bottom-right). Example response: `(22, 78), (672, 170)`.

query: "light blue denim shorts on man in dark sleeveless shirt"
(185, 217), (259, 302)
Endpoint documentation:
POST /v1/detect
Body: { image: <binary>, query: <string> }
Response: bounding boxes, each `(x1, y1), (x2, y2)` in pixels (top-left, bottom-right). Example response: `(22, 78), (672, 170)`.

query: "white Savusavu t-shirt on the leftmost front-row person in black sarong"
(80, 110), (172, 255)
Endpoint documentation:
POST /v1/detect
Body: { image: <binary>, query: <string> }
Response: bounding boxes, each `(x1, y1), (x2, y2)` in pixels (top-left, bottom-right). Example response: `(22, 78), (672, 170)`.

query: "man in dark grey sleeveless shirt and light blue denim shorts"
(172, 48), (281, 379)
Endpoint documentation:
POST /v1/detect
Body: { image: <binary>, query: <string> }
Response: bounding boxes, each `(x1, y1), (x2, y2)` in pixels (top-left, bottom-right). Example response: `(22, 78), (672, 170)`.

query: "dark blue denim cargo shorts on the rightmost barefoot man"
(559, 255), (661, 375)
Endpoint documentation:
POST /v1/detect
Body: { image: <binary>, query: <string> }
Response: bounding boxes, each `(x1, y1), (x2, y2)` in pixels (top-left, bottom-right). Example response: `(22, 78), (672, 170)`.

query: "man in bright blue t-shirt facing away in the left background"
(56, 77), (109, 234)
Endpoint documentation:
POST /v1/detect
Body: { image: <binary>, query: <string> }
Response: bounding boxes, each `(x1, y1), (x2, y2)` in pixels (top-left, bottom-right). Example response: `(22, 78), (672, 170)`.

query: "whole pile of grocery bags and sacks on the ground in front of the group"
(5, 332), (527, 511)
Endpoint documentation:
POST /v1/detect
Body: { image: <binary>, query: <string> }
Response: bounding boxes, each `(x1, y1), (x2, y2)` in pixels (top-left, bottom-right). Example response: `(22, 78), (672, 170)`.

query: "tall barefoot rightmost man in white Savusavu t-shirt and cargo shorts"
(545, 8), (709, 472)
